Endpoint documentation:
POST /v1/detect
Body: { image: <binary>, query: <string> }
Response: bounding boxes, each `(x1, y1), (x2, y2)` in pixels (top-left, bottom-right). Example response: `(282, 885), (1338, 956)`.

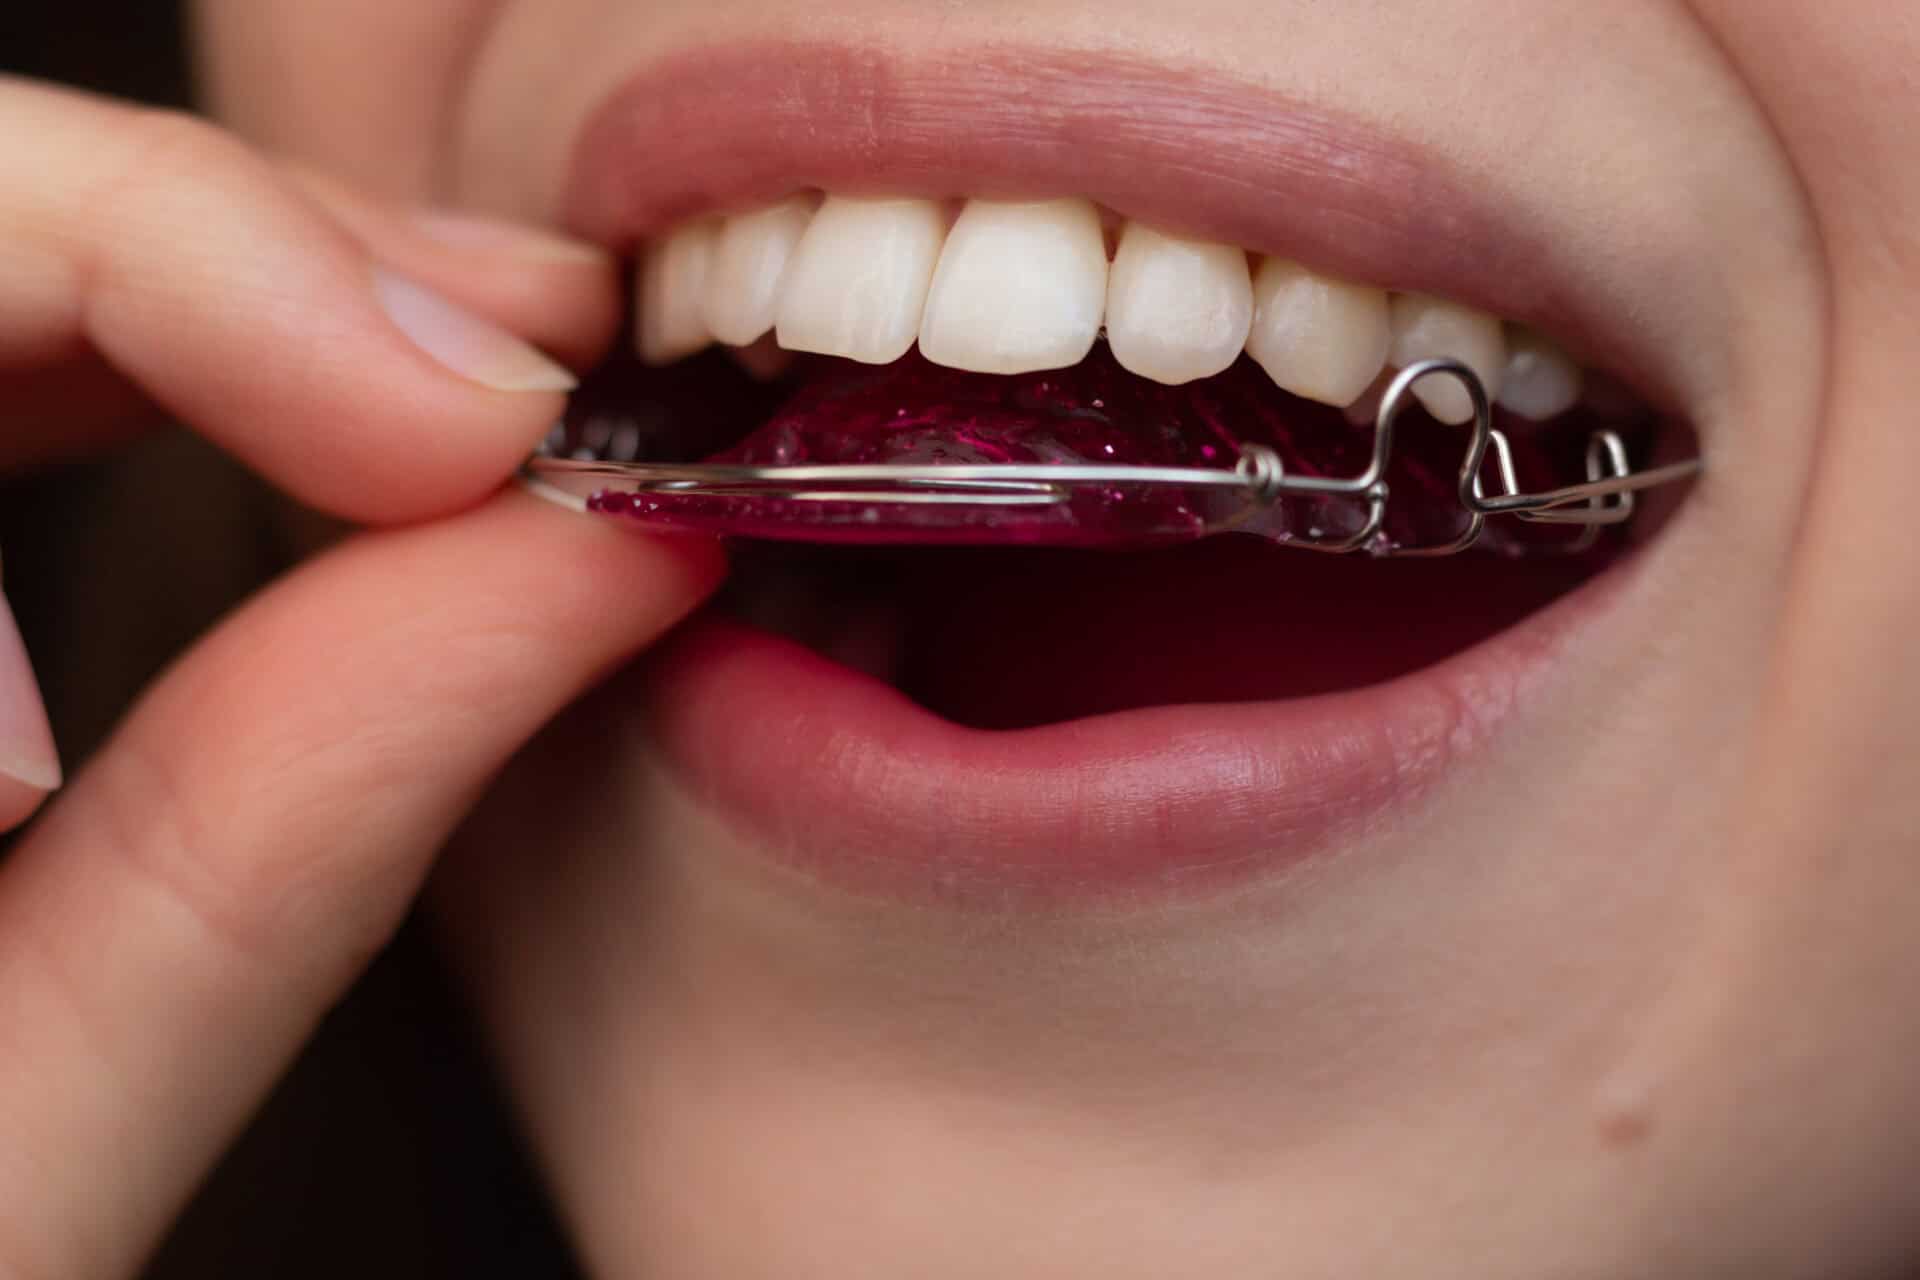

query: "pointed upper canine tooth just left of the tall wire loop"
(1246, 257), (1392, 405)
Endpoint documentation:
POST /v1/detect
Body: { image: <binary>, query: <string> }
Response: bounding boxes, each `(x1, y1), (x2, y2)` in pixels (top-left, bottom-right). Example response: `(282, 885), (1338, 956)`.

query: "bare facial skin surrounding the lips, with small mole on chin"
(200, 0), (1920, 1280)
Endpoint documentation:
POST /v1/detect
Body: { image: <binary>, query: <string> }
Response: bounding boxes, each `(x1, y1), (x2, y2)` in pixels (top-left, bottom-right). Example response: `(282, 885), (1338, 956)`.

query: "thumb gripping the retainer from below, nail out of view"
(0, 493), (718, 1276)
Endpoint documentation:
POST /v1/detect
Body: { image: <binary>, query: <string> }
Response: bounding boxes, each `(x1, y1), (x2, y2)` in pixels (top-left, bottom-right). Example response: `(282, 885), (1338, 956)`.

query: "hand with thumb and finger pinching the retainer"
(0, 79), (720, 1280)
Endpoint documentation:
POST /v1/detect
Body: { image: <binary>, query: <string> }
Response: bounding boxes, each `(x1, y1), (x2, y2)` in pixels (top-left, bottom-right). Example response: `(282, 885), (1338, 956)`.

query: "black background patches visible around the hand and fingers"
(0, 0), (576, 1280)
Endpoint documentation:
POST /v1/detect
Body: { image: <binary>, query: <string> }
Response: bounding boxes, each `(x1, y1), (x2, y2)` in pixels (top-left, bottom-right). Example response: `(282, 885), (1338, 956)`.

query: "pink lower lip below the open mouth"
(651, 555), (1642, 904)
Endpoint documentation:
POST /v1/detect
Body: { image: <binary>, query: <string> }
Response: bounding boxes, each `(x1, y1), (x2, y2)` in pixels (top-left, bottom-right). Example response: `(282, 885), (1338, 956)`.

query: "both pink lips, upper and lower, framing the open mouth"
(566, 44), (1668, 900)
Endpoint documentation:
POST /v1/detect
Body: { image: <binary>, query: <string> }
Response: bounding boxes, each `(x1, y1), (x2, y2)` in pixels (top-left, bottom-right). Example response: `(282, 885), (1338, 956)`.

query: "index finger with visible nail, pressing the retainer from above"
(0, 81), (611, 520)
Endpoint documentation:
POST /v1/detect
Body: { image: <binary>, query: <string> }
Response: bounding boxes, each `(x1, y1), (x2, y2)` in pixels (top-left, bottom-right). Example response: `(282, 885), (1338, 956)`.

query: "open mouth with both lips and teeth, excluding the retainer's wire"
(547, 46), (1693, 902)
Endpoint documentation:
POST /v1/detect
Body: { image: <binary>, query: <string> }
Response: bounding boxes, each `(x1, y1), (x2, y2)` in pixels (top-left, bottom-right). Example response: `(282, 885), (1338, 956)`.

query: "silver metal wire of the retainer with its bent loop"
(526, 359), (1701, 557)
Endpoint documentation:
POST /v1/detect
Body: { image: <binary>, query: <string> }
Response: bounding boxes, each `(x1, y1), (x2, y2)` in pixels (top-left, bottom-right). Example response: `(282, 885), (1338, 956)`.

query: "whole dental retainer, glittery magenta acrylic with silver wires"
(524, 351), (1699, 557)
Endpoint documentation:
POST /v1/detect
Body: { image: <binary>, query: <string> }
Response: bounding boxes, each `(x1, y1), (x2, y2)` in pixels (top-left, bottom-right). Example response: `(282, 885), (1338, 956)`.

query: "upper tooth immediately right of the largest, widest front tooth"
(1105, 223), (1254, 386)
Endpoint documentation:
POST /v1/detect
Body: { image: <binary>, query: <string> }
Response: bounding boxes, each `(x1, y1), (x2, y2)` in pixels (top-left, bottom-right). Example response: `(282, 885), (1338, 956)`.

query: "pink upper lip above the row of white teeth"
(563, 40), (1720, 420)
